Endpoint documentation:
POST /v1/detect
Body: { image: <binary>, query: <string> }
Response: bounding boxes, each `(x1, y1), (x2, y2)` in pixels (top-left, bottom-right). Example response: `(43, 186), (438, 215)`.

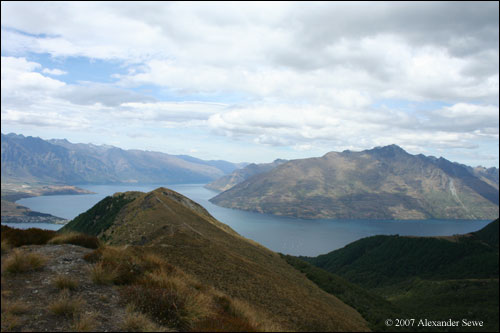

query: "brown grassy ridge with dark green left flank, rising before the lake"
(62, 188), (368, 332)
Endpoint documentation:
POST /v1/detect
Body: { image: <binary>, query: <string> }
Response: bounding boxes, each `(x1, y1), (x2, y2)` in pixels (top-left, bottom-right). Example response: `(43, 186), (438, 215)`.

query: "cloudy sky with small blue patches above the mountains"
(1, 1), (499, 167)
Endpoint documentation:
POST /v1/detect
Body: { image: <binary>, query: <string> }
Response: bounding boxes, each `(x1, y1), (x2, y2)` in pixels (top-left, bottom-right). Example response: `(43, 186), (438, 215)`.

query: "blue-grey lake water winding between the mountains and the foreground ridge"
(10, 184), (490, 256)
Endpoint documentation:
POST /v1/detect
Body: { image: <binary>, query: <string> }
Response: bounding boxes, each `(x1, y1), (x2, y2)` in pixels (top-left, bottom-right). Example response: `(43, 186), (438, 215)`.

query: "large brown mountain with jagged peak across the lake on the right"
(210, 145), (499, 219)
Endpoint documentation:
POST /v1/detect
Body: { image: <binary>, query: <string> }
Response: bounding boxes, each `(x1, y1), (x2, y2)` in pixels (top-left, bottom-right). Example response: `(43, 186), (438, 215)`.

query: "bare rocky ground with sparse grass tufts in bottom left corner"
(1, 244), (127, 332)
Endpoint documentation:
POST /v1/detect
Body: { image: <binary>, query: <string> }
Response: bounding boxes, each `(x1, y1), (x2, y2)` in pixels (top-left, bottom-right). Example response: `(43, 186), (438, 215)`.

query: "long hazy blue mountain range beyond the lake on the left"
(2, 133), (238, 184)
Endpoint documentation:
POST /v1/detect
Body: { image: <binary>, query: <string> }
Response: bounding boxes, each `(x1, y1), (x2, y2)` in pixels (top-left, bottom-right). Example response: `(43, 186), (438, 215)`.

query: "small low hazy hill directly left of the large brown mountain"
(205, 159), (287, 192)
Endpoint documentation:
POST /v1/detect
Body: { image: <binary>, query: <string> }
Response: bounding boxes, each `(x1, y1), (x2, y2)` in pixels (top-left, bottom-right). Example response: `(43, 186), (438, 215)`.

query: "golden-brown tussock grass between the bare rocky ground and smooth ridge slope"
(88, 246), (282, 332)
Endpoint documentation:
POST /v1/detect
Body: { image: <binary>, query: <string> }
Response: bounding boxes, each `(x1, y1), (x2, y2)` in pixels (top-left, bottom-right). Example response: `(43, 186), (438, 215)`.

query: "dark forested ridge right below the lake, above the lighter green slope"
(305, 232), (498, 287)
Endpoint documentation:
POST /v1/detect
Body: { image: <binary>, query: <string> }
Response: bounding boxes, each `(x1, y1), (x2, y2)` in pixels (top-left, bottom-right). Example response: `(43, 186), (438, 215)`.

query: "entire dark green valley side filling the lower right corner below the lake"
(294, 219), (499, 332)
